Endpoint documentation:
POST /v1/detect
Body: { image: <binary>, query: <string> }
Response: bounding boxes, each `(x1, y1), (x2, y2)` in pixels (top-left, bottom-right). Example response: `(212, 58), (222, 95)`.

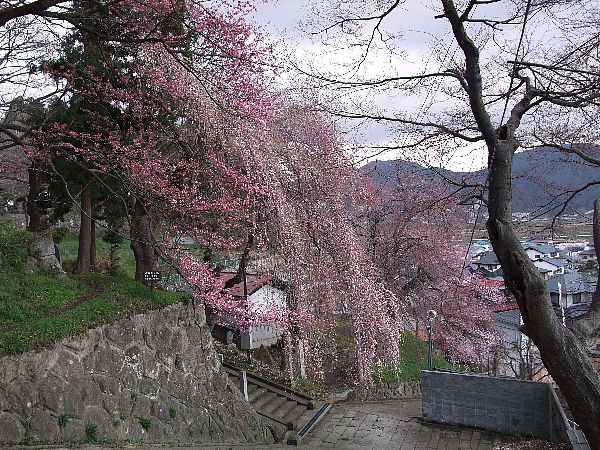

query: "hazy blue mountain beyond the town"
(361, 147), (600, 213)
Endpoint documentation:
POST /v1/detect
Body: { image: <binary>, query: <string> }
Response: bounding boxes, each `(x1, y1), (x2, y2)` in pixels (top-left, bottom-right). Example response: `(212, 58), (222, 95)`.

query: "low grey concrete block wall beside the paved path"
(421, 371), (568, 442)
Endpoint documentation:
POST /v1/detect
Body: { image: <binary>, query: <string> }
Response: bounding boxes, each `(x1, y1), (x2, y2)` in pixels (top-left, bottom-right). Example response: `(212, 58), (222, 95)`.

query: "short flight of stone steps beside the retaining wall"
(223, 362), (316, 431)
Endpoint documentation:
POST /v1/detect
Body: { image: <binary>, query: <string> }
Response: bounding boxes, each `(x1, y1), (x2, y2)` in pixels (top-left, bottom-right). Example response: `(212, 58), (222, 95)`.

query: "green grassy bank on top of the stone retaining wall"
(0, 225), (188, 356)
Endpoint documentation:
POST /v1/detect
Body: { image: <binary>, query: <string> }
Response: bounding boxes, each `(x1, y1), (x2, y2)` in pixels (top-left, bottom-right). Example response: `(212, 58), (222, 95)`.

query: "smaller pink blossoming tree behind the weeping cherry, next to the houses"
(358, 168), (504, 365)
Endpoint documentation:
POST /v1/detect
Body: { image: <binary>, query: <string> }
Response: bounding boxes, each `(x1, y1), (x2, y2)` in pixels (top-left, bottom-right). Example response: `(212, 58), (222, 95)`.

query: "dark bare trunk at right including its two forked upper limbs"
(441, 0), (600, 442)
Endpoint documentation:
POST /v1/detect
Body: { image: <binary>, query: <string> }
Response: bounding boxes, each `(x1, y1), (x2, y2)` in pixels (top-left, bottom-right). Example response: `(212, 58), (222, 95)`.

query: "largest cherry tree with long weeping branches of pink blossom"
(10, 2), (418, 381)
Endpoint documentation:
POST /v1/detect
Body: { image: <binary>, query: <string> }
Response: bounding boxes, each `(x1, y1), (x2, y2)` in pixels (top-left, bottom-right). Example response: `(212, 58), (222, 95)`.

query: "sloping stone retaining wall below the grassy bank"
(0, 304), (272, 444)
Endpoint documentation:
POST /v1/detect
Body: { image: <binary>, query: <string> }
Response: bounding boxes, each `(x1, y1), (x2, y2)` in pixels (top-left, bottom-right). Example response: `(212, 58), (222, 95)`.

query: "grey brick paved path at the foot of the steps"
(302, 399), (514, 450)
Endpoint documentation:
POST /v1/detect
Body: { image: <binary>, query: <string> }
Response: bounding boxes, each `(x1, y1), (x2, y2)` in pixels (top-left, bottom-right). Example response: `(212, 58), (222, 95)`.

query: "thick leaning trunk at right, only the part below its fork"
(487, 140), (600, 449)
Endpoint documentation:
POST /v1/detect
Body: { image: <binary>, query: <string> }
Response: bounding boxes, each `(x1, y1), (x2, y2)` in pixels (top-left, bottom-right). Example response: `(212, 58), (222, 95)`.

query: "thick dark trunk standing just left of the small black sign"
(130, 199), (157, 282)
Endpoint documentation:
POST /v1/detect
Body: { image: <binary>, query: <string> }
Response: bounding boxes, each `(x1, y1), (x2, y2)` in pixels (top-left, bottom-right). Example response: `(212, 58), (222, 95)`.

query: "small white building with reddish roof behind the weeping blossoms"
(207, 272), (286, 350)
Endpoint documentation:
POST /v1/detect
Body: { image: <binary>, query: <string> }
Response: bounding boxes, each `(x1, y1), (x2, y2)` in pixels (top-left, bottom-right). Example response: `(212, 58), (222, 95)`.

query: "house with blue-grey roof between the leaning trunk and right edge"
(547, 272), (596, 308)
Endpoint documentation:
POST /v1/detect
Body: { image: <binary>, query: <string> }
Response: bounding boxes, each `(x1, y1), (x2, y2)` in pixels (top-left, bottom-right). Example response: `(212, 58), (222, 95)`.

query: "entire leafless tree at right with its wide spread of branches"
(313, 0), (600, 442)
